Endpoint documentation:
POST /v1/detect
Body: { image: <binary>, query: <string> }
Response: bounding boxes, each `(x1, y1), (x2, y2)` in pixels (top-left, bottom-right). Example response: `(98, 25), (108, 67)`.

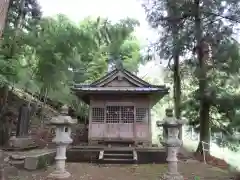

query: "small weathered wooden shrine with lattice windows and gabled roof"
(73, 69), (169, 146)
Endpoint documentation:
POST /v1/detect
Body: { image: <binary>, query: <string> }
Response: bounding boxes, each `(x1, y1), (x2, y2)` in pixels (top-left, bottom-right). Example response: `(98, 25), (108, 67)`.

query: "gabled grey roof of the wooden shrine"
(72, 69), (169, 105)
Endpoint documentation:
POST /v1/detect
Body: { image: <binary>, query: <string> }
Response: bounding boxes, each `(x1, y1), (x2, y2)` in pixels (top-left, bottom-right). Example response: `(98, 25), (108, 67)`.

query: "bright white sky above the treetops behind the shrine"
(39, 0), (156, 42)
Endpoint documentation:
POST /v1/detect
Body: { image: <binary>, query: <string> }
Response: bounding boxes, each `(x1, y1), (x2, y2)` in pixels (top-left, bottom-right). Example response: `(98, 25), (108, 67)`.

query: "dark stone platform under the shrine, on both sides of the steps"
(67, 145), (167, 164)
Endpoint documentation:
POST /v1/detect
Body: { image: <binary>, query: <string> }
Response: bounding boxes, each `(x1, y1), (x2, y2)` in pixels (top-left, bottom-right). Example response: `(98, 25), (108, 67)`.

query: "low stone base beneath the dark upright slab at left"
(4, 136), (37, 150)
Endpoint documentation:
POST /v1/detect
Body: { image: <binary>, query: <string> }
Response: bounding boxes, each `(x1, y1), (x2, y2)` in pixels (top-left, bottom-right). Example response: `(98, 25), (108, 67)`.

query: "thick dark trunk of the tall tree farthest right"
(194, 0), (210, 153)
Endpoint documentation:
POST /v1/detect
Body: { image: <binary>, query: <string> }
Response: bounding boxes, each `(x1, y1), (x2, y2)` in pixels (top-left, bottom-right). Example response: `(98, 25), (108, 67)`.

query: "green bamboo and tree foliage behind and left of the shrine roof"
(0, 0), (143, 121)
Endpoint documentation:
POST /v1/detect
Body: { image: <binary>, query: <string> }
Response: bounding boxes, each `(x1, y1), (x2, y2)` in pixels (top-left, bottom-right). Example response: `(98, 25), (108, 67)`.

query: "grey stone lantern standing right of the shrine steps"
(157, 109), (184, 180)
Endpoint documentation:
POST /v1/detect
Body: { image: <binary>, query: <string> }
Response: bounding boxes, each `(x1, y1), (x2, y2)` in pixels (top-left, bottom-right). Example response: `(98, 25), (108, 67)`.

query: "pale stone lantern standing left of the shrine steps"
(48, 106), (77, 179)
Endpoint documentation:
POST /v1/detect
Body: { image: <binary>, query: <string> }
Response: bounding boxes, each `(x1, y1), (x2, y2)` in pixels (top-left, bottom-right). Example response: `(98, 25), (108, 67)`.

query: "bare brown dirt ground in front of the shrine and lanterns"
(6, 161), (231, 180)
